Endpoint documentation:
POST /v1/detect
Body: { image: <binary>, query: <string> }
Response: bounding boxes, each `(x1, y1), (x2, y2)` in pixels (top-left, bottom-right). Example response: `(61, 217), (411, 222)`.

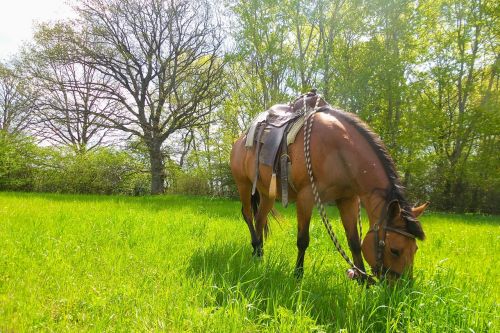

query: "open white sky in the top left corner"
(0, 0), (72, 61)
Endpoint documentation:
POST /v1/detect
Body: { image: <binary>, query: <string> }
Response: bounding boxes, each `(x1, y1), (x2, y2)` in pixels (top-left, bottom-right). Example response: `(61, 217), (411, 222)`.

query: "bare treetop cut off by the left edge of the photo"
(0, 63), (35, 133)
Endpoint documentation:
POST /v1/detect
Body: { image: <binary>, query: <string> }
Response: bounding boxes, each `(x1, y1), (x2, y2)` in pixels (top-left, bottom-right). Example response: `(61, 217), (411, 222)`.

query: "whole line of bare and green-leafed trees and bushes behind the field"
(0, 0), (500, 213)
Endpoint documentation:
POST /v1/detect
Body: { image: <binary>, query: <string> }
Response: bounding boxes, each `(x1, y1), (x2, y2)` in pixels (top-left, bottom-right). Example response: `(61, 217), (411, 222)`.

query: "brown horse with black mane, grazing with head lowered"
(231, 93), (427, 279)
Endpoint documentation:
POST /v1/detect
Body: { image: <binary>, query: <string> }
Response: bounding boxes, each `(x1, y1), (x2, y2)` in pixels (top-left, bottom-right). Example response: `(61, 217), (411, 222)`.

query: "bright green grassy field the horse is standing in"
(0, 193), (500, 332)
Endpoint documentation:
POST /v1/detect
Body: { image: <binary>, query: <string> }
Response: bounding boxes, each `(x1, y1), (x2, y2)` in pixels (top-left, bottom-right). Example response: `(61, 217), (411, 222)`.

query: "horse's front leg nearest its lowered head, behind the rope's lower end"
(337, 197), (365, 271)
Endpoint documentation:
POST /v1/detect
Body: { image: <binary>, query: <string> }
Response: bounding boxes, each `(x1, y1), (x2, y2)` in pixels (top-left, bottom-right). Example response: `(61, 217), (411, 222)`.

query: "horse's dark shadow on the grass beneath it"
(186, 241), (442, 332)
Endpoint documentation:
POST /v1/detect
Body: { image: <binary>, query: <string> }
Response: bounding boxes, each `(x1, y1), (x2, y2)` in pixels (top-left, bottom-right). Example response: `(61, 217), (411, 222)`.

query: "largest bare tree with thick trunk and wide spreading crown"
(56, 0), (224, 194)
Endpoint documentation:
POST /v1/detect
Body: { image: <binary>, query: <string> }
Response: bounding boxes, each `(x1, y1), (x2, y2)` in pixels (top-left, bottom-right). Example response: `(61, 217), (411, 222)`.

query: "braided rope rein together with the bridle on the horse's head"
(302, 94), (416, 283)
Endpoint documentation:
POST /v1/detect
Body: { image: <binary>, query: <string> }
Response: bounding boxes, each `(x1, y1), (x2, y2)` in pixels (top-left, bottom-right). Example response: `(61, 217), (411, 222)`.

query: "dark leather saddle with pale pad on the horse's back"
(245, 91), (326, 207)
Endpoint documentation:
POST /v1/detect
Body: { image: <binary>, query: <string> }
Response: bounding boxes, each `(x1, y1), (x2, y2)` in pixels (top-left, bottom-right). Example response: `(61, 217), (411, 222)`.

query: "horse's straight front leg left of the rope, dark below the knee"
(295, 190), (313, 279)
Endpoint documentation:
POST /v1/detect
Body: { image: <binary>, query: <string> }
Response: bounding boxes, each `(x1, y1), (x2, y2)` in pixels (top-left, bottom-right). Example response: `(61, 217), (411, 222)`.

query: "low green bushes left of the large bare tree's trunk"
(0, 137), (150, 195)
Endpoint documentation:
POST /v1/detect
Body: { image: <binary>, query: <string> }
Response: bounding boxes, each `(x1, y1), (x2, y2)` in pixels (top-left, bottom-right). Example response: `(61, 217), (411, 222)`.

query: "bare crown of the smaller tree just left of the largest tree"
(24, 38), (119, 153)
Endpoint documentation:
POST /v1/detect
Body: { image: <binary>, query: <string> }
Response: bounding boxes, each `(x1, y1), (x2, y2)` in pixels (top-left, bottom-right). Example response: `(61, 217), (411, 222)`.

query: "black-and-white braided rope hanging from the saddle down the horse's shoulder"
(303, 95), (370, 278)
